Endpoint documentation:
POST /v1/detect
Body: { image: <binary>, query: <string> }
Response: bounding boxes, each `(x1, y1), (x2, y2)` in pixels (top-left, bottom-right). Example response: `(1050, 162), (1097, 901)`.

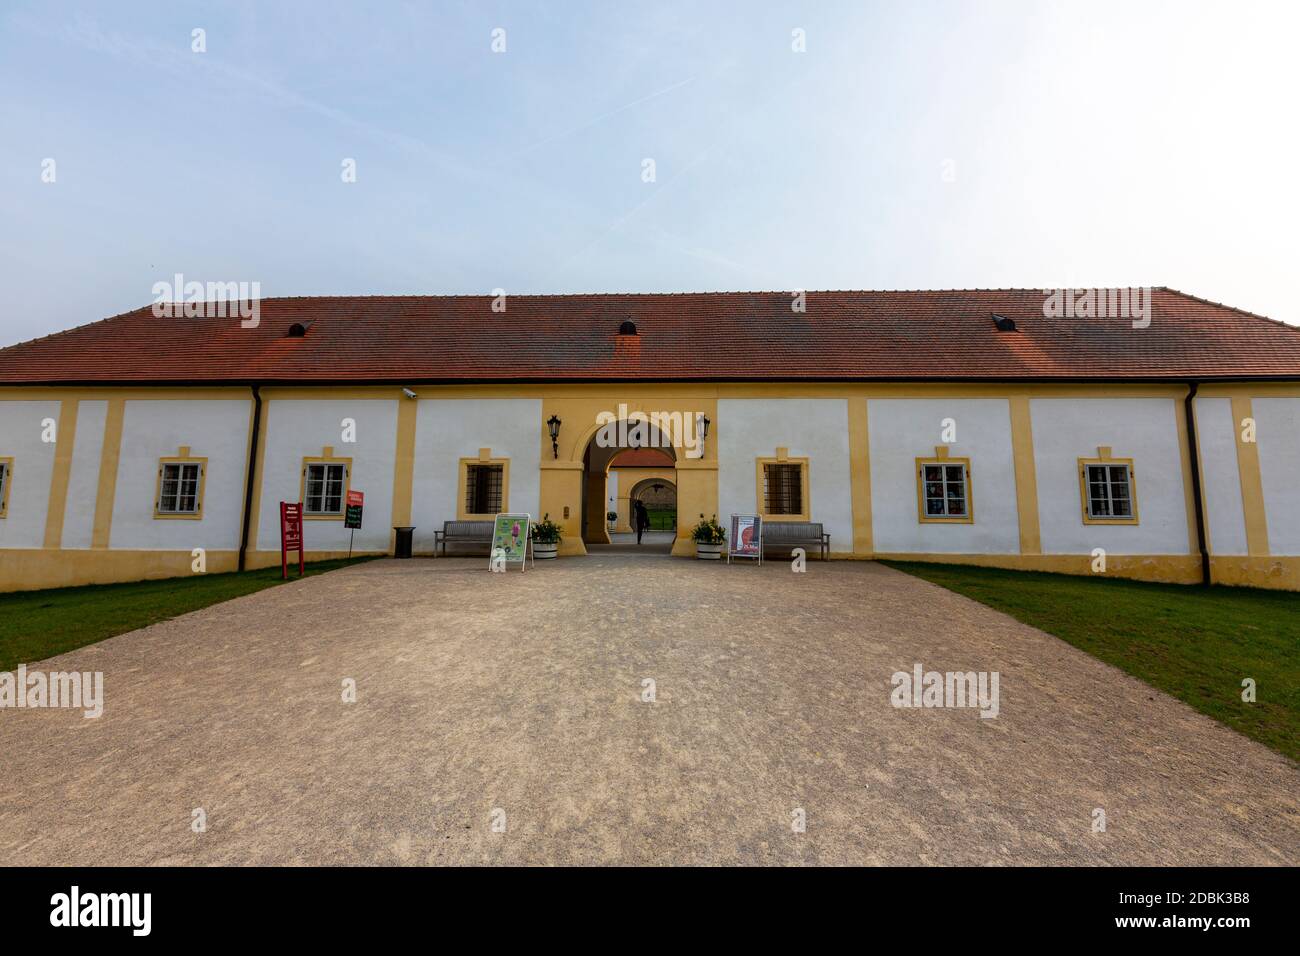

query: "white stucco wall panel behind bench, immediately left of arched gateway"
(411, 398), (543, 551)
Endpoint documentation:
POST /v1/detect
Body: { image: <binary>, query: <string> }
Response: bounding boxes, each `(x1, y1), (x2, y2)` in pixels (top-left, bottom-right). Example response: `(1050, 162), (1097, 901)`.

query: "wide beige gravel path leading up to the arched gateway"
(0, 553), (1300, 865)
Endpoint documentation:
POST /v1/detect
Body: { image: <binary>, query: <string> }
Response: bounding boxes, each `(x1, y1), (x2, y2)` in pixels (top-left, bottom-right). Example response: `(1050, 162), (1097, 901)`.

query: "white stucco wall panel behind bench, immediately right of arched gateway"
(712, 398), (853, 551)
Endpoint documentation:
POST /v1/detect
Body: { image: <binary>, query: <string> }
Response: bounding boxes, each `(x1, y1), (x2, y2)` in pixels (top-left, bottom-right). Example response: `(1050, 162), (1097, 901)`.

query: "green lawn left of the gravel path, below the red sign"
(0, 557), (371, 671)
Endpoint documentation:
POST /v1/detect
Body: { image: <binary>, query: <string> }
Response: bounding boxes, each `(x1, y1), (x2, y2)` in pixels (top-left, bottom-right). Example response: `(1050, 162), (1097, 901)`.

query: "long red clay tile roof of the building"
(0, 289), (1300, 384)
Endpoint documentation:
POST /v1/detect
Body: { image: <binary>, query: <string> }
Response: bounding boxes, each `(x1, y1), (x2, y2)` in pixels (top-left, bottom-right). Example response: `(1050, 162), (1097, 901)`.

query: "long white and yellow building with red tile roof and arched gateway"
(0, 289), (1300, 591)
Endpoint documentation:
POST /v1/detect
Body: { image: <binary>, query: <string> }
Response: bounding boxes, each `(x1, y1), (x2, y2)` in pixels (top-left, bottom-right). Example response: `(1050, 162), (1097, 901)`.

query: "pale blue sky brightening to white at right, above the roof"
(0, 0), (1300, 345)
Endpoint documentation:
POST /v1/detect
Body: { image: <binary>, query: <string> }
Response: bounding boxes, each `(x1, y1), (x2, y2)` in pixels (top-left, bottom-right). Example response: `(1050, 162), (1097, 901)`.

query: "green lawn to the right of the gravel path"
(884, 561), (1300, 760)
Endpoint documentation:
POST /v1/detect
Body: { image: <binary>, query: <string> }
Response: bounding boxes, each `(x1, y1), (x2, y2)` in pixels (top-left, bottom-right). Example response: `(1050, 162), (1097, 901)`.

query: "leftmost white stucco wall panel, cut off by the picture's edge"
(0, 402), (60, 548)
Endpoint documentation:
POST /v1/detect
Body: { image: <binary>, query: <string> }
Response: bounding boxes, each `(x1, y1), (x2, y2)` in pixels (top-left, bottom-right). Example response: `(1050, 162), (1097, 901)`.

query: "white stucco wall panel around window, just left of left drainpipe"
(113, 399), (253, 551)
